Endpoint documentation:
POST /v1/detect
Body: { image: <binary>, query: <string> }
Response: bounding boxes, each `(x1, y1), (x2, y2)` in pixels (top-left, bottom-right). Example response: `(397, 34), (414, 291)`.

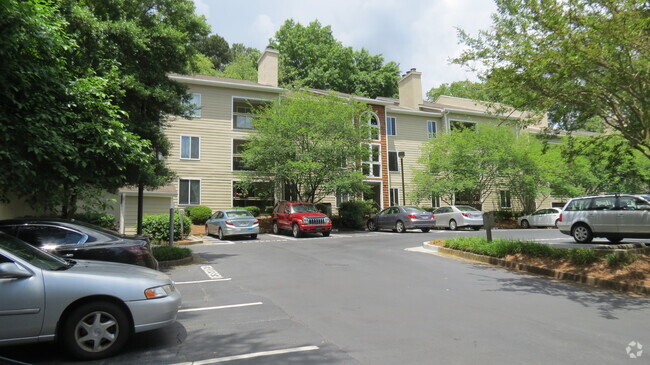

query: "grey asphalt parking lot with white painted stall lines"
(0, 229), (650, 365)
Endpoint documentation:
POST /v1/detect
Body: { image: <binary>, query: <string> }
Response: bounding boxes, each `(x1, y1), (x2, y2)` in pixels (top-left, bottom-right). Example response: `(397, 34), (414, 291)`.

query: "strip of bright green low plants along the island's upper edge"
(445, 237), (600, 265)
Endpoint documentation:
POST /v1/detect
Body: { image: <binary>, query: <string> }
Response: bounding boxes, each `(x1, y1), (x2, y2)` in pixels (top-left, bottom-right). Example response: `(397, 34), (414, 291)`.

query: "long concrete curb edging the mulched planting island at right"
(422, 242), (650, 295)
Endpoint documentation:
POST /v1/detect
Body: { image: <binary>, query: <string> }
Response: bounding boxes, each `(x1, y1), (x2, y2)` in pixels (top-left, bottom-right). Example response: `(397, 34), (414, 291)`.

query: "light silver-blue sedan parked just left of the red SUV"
(205, 209), (260, 240)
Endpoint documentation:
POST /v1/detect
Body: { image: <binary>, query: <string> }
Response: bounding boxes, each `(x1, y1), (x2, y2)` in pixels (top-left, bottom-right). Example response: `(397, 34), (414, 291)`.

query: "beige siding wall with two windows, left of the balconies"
(165, 85), (278, 210)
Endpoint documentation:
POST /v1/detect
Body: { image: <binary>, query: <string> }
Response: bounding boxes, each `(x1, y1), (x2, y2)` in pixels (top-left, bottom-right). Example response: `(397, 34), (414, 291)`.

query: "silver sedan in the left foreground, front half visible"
(0, 233), (181, 360)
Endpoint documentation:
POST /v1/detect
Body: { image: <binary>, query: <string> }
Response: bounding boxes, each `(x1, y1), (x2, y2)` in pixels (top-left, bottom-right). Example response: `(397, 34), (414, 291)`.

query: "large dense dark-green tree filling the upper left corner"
(0, 0), (149, 216)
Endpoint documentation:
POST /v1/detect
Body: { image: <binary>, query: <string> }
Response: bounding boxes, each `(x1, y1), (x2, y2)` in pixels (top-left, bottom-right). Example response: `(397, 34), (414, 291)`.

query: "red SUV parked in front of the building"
(273, 202), (332, 237)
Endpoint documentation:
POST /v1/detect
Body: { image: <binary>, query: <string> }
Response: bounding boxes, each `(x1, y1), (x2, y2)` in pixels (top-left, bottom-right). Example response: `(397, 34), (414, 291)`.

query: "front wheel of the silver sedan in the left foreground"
(57, 302), (132, 360)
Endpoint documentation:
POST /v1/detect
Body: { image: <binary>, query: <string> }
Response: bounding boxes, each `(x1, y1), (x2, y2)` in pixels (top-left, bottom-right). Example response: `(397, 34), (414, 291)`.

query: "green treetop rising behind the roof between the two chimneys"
(269, 19), (399, 97)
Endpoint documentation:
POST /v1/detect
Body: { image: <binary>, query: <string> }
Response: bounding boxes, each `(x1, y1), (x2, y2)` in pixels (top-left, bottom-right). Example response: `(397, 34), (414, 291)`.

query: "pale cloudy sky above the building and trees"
(194, 0), (496, 93)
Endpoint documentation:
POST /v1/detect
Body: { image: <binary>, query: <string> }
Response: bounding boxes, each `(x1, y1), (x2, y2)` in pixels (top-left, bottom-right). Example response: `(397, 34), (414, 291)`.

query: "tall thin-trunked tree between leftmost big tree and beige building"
(61, 0), (209, 228)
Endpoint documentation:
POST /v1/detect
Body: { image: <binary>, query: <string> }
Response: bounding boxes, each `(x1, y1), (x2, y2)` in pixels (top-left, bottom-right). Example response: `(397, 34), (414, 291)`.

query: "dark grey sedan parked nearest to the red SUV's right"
(367, 206), (436, 233)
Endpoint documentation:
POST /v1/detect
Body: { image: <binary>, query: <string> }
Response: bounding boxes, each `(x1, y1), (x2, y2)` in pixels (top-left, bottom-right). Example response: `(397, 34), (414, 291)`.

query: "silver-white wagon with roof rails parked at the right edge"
(558, 194), (650, 243)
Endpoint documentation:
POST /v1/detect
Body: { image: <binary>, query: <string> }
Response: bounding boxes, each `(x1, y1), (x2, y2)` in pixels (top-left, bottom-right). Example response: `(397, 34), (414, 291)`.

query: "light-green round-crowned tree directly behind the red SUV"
(242, 92), (369, 202)
